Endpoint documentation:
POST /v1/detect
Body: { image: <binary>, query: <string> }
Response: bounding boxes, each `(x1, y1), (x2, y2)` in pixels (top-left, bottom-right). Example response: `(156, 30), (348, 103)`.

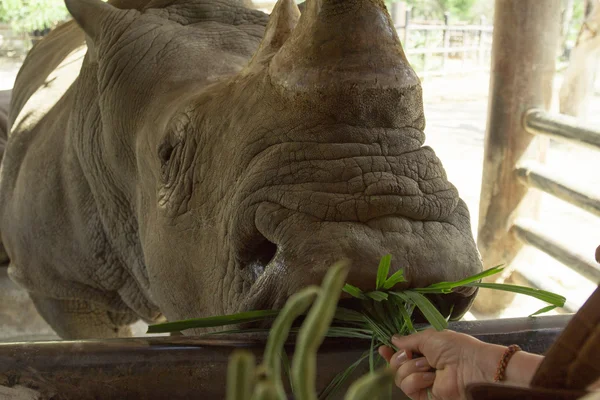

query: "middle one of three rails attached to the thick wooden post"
(516, 163), (600, 217)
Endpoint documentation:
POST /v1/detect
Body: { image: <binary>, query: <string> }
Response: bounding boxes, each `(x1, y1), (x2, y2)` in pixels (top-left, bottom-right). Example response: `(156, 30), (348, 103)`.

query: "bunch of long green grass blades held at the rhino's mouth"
(148, 255), (565, 400)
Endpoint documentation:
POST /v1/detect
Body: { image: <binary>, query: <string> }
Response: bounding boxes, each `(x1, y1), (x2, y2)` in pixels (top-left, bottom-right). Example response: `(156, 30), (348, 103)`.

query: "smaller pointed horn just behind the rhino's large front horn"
(249, 0), (300, 67)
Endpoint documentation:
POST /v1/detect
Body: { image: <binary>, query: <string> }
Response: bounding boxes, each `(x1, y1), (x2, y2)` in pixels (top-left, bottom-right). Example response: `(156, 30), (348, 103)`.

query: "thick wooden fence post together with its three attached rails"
(475, 0), (600, 313)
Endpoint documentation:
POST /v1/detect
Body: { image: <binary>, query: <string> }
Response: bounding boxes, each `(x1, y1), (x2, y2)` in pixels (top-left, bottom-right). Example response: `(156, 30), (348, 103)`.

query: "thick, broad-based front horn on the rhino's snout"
(269, 0), (420, 90)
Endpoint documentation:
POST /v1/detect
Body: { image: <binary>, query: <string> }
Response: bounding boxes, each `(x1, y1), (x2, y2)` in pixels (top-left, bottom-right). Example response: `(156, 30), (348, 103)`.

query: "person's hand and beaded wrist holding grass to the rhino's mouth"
(379, 329), (542, 400)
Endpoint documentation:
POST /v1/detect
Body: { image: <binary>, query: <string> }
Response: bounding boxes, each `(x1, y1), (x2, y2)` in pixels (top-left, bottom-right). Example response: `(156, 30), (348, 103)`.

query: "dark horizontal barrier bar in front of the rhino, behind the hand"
(0, 315), (571, 400)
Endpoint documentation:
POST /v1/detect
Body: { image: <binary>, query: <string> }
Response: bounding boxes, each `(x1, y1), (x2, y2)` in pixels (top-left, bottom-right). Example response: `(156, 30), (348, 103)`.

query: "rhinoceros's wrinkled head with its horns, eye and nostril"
(67, 0), (481, 328)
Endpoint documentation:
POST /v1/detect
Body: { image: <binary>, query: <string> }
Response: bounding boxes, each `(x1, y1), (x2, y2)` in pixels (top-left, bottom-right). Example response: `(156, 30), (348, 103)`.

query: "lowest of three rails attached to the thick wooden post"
(511, 219), (600, 284)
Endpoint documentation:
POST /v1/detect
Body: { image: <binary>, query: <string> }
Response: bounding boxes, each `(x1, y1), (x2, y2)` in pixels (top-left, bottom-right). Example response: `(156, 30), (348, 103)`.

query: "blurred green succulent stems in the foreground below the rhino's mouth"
(227, 262), (393, 400)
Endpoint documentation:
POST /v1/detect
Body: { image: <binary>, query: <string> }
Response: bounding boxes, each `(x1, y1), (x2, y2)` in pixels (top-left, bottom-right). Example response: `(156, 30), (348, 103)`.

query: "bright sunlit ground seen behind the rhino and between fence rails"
(0, 59), (600, 341)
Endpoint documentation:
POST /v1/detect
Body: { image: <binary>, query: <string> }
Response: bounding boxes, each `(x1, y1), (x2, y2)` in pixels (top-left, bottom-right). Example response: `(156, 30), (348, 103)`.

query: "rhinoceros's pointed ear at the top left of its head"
(65, 0), (126, 41)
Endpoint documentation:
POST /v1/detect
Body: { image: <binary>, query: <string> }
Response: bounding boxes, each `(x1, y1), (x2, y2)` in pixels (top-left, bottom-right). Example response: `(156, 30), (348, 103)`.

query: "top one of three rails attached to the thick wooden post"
(524, 109), (600, 150)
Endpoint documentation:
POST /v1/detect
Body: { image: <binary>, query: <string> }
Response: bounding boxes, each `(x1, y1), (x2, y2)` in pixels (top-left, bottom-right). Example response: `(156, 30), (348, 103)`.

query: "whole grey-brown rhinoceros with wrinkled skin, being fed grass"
(0, 0), (482, 338)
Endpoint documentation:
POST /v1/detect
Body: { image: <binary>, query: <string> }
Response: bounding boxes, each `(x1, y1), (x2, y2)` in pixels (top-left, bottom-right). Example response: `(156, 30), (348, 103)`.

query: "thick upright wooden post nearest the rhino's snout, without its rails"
(474, 0), (561, 314)
